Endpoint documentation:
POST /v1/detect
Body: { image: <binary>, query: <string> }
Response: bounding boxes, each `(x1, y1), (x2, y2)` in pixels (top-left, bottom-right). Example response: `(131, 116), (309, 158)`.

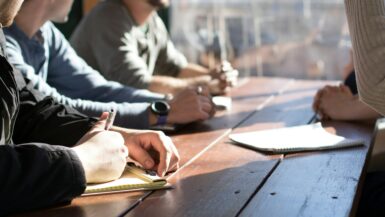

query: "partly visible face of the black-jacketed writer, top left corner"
(0, 0), (23, 26)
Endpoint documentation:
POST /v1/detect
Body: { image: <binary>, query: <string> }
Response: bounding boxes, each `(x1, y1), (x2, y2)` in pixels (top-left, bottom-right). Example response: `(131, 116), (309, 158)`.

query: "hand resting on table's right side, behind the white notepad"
(313, 85), (357, 120)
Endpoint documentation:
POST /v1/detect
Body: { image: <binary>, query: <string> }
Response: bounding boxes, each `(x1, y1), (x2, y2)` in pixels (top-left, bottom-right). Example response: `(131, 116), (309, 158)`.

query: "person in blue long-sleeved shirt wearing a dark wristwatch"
(4, 0), (214, 131)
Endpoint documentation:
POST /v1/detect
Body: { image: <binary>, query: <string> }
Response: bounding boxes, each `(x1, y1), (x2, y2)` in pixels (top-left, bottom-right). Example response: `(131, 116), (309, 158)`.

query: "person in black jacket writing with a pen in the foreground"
(0, 0), (179, 216)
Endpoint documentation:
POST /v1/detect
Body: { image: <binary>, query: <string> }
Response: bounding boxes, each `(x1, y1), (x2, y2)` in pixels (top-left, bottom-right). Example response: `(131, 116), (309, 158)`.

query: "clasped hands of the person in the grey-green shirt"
(209, 61), (238, 94)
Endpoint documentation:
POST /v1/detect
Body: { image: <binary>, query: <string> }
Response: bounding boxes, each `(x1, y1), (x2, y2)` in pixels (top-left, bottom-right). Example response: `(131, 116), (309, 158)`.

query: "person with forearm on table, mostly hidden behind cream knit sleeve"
(313, 54), (381, 121)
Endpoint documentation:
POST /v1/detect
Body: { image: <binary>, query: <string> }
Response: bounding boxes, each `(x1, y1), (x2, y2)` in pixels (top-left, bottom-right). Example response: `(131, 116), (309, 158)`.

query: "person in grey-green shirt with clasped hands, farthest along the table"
(70, 0), (237, 94)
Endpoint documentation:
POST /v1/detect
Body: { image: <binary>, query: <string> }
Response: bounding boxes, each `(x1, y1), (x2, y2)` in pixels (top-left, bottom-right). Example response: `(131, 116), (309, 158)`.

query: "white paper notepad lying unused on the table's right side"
(229, 122), (364, 153)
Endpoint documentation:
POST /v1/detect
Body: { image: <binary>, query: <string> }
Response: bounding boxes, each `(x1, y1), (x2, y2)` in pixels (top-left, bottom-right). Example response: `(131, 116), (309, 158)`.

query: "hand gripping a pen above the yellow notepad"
(72, 112), (128, 183)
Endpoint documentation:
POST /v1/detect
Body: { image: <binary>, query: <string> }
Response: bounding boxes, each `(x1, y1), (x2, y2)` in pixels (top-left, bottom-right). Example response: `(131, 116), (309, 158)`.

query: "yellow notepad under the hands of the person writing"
(82, 163), (171, 196)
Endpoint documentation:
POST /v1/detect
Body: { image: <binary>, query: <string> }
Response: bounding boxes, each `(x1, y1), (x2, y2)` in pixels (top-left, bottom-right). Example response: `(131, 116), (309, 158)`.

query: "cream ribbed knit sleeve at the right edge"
(345, 0), (385, 114)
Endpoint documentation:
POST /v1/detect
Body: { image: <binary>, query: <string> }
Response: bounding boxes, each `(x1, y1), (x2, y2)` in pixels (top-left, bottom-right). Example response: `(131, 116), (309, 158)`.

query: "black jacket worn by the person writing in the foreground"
(0, 30), (95, 216)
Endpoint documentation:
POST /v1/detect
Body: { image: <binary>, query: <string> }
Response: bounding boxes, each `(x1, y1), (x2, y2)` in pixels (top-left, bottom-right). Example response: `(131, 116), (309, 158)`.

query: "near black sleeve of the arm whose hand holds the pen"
(0, 143), (86, 216)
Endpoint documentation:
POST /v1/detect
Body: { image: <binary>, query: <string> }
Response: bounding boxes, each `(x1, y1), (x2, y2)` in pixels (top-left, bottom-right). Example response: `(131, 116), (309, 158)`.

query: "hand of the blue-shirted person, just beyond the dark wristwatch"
(167, 88), (215, 124)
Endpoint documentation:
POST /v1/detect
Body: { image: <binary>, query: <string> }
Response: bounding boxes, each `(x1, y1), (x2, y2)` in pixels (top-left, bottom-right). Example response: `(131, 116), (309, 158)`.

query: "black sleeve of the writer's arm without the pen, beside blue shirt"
(13, 83), (95, 146)
